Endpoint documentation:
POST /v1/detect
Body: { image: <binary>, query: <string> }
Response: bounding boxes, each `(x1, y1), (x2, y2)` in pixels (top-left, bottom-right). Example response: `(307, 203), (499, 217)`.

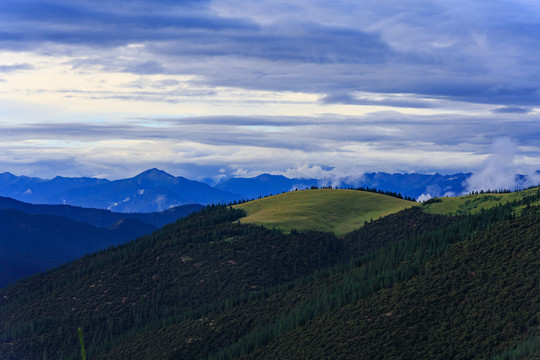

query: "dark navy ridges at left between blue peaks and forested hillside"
(0, 197), (202, 288)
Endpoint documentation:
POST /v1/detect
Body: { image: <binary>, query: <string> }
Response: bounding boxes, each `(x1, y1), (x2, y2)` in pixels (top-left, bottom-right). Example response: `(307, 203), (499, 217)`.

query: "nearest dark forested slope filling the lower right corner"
(241, 214), (540, 359)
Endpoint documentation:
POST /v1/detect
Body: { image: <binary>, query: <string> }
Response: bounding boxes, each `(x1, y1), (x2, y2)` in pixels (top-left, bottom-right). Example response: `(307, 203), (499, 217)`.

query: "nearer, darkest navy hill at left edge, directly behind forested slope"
(0, 209), (155, 287)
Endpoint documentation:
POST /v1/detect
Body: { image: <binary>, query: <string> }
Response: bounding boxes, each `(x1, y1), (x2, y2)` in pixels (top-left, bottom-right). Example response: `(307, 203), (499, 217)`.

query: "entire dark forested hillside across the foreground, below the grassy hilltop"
(0, 191), (540, 360)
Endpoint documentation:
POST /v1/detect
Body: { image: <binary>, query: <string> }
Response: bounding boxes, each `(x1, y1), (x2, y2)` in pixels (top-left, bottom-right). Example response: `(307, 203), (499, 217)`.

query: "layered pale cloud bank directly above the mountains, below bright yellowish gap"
(0, 112), (540, 181)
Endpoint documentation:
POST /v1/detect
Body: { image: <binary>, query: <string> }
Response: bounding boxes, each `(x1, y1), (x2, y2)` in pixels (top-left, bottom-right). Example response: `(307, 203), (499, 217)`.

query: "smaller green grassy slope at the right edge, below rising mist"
(422, 187), (540, 215)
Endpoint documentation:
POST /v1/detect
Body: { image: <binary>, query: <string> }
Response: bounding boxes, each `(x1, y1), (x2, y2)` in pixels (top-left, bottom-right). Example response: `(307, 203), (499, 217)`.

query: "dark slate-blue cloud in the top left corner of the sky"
(0, 0), (250, 48)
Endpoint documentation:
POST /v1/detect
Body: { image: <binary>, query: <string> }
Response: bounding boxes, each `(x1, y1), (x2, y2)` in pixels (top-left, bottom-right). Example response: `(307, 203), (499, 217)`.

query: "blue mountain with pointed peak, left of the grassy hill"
(0, 169), (236, 212)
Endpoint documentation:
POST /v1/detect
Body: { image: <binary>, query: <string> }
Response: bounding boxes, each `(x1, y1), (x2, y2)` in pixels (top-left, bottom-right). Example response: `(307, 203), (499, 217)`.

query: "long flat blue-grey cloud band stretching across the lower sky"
(0, 112), (540, 151)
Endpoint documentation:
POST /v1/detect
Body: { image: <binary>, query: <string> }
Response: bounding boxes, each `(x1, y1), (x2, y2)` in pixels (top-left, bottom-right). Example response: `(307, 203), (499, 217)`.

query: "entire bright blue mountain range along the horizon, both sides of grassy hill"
(0, 169), (470, 212)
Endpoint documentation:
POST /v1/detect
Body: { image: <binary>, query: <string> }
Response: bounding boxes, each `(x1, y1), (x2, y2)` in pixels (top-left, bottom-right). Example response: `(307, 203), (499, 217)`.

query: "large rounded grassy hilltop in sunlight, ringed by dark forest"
(235, 189), (414, 236)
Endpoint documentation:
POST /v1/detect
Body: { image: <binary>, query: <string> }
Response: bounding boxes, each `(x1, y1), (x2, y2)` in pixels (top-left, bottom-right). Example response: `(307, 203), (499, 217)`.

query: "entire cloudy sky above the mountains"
(0, 0), (540, 186)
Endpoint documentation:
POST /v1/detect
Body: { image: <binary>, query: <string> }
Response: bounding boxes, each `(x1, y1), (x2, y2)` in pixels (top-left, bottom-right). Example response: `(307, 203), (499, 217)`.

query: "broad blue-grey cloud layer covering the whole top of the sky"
(0, 0), (540, 108)
